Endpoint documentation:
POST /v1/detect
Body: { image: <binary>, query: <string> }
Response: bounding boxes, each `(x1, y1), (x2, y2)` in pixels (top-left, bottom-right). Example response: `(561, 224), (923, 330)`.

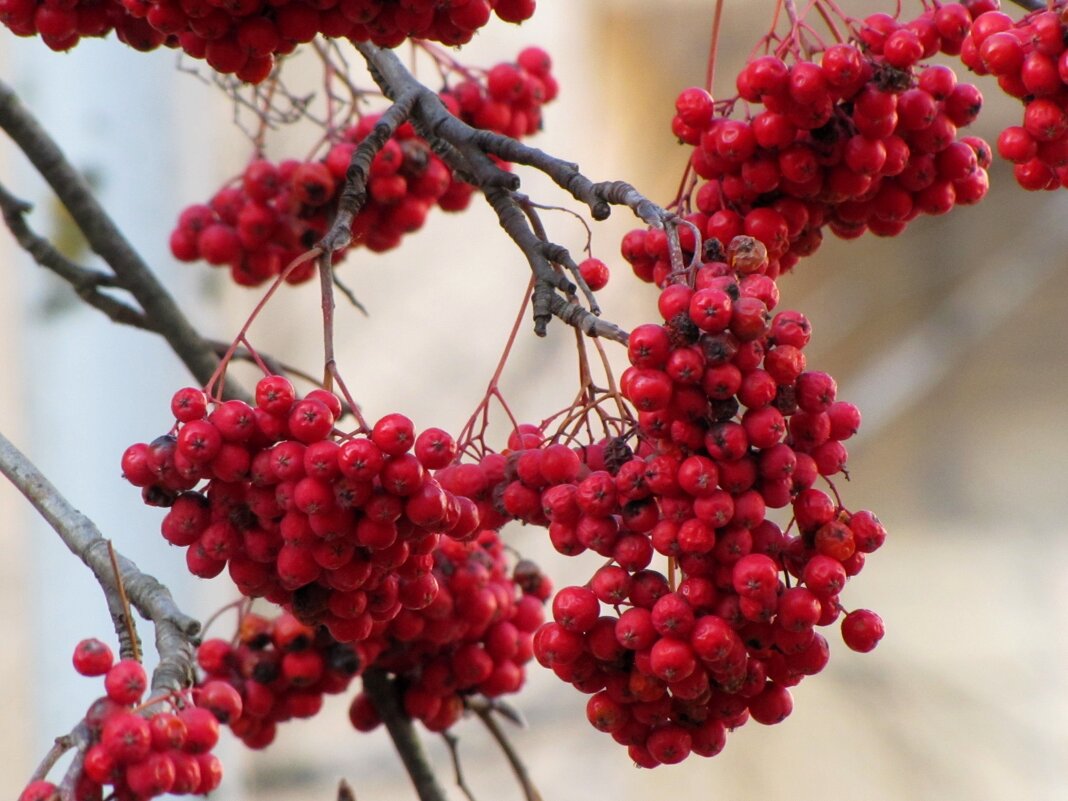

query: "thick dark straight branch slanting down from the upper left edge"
(0, 81), (245, 396)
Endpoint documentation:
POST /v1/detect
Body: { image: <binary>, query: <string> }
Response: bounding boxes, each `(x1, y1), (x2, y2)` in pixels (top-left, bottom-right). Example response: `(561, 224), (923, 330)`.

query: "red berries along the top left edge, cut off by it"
(0, 0), (535, 75)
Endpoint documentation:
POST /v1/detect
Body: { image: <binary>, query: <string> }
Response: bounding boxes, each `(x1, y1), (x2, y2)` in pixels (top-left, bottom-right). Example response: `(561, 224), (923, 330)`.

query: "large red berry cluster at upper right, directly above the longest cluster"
(623, 3), (990, 286)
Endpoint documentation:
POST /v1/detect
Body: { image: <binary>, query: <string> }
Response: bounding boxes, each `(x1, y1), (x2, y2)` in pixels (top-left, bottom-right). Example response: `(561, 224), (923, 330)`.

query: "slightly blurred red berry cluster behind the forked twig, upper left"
(171, 47), (557, 286)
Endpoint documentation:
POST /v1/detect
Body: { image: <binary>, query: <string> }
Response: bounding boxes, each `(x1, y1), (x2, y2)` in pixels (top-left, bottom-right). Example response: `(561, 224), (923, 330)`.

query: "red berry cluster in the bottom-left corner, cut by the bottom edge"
(19, 640), (231, 801)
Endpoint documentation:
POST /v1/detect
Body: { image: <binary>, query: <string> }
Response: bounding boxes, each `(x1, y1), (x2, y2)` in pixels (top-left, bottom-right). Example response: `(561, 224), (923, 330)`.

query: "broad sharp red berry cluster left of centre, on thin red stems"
(122, 376), (480, 643)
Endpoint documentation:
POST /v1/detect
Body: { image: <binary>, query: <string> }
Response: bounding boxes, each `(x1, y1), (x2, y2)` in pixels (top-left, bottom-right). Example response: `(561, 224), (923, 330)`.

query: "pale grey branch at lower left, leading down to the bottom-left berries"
(0, 434), (201, 693)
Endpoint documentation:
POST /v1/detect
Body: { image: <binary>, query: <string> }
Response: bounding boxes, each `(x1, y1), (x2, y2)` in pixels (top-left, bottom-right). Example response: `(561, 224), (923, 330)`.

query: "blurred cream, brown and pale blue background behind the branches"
(0, 0), (1068, 801)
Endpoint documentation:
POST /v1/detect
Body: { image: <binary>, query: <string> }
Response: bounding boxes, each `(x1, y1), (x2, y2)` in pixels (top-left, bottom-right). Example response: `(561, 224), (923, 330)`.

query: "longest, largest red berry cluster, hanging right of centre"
(484, 238), (885, 766)
